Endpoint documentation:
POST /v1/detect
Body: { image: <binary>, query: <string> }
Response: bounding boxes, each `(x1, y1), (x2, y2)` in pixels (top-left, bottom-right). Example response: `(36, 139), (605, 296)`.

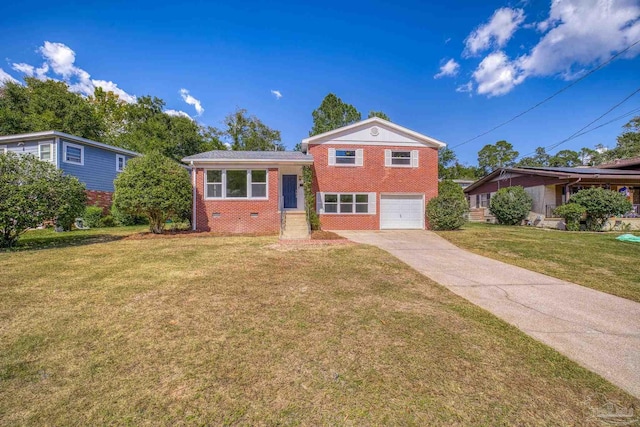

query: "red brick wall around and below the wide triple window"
(196, 168), (280, 234)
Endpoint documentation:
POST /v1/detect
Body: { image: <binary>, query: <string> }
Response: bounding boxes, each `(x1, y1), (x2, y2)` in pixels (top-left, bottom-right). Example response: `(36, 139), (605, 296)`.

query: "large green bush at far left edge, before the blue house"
(0, 153), (86, 247)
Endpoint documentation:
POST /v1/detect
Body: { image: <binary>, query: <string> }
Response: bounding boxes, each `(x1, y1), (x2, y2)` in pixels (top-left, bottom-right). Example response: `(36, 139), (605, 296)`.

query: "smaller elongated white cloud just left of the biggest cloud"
(464, 7), (524, 56)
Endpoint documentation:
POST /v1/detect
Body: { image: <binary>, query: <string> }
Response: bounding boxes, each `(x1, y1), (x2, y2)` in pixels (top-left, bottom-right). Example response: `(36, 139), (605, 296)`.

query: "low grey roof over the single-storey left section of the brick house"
(182, 150), (313, 164)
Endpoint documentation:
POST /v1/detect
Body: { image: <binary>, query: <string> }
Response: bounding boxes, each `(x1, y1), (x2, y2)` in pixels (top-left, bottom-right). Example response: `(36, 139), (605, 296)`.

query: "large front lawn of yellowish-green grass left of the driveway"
(0, 229), (640, 426)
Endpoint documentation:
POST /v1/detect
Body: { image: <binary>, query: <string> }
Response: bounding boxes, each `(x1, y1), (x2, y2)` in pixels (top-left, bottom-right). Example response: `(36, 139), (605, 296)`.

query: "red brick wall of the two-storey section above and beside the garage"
(309, 144), (438, 230)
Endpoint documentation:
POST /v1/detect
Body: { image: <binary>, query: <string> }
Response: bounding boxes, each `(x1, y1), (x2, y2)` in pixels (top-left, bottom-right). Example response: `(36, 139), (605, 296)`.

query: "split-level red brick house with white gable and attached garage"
(183, 117), (445, 238)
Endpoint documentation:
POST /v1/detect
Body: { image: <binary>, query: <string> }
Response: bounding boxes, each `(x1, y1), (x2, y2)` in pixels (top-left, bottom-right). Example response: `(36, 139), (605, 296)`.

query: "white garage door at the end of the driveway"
(380, 194), (424, 228)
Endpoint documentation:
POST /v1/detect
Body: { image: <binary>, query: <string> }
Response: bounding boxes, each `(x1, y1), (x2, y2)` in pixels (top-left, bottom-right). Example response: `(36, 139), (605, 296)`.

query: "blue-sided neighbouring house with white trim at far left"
(0, 131), (140, 207)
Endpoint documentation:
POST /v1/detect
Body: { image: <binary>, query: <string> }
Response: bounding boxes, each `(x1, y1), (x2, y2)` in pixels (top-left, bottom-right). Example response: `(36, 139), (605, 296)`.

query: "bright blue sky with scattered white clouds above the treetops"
(0, 0), (640, 164)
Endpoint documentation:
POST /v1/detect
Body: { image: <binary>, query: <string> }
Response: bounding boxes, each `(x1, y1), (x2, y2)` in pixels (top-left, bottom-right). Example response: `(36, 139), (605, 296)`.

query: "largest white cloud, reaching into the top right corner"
(473, 0), (640, 96)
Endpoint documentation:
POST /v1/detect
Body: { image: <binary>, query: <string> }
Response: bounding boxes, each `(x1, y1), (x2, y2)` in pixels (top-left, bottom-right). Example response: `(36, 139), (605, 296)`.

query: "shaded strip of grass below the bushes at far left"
(0, 227), (141, 253)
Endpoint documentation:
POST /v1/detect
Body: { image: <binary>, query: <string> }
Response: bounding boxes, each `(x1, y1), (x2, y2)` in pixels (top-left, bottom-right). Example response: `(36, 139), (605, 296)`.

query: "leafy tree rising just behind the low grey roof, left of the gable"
(224, 108), (284, 151)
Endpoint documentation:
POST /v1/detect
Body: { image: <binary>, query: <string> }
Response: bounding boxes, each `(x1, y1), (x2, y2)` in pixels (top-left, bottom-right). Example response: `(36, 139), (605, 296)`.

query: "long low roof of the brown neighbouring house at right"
(464, 167), (640, 192)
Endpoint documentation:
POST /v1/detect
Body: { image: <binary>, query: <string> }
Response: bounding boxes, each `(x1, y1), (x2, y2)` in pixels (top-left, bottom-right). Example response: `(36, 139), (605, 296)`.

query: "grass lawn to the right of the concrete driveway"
(438, 223), (640, 302)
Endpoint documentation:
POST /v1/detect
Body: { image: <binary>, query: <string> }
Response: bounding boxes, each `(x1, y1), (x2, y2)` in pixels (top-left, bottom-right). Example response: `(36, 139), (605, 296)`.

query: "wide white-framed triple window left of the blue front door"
(205, 169), (269, 200)
